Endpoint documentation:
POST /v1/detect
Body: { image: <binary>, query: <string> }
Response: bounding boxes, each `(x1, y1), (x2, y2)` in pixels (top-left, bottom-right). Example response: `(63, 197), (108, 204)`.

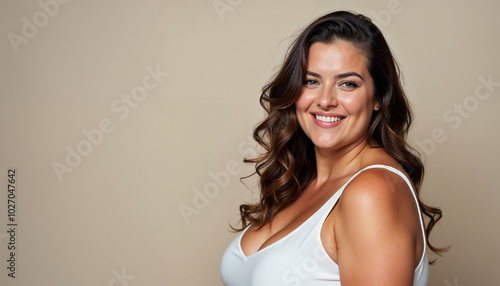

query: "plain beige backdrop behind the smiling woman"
(0, 0), (500, 286)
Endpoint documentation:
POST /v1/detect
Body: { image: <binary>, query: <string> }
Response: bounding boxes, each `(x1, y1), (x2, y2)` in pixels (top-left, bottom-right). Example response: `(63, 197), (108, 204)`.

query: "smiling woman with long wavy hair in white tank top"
(221, 11), (443, 286)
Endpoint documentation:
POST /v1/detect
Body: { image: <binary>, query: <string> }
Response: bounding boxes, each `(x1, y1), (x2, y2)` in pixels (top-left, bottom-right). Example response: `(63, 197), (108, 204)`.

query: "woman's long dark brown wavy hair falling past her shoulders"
(235, 11), (447, 254)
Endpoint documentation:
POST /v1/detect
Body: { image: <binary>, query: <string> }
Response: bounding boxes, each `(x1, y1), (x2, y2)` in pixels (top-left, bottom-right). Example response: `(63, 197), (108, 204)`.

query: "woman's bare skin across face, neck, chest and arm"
(241, 41), (424, 286)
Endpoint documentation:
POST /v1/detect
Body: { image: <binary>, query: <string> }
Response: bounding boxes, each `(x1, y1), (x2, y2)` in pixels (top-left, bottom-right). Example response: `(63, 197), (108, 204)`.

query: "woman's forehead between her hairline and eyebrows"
(307, 40), (368, 75)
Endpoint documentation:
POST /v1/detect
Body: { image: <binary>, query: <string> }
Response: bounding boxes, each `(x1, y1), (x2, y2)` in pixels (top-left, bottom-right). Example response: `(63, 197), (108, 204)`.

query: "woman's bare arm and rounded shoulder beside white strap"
(334, 169), (421, 286)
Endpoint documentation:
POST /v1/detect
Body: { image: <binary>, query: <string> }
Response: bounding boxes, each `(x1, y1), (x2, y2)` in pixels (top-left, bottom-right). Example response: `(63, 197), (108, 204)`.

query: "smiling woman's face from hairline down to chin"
(295, 40), (376, 150)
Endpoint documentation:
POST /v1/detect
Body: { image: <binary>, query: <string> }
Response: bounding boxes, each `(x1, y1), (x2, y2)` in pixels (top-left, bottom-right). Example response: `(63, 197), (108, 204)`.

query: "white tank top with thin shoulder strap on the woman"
(220, 165), (429, 286)
